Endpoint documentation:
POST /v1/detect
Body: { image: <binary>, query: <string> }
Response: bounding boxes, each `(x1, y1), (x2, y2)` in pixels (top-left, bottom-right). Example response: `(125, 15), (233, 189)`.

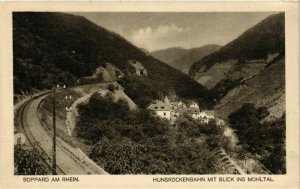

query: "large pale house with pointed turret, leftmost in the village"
(147, 96), (171, 120)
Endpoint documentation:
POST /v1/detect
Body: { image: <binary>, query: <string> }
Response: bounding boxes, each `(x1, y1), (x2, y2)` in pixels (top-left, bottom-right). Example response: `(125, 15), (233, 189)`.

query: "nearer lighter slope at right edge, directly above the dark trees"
(215, 57), (285, 119)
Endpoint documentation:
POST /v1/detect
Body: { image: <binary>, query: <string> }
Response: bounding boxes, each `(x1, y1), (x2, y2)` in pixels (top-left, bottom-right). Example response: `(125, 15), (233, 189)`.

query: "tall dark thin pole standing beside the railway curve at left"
(52, 87), (56, 175)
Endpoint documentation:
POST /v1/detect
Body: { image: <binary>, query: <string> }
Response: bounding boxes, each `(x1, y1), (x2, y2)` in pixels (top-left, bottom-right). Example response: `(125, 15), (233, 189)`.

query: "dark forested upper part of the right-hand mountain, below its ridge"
(189, 13), (285, 76)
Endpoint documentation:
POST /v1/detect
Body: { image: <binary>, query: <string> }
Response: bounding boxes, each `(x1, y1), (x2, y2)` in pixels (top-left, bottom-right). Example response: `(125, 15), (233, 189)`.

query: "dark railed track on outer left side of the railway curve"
(17, 92), (66, 175)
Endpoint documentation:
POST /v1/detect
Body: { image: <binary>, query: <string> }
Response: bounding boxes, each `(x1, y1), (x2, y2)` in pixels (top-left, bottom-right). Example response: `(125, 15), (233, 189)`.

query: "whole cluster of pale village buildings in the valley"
(147, 96), (215, 123)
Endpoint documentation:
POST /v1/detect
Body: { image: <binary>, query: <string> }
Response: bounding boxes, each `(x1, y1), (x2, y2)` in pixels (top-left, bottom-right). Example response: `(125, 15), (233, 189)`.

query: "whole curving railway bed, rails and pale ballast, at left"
(15, 89), (107, 175)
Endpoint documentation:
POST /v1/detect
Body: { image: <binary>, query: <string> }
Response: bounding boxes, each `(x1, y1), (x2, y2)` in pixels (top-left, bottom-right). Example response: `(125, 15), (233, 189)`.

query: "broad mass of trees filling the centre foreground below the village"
(75, 94), (225, 174)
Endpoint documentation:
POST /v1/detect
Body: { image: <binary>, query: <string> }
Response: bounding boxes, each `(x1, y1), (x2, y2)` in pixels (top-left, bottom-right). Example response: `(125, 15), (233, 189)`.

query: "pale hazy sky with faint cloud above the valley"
(73, 12), (274, 51)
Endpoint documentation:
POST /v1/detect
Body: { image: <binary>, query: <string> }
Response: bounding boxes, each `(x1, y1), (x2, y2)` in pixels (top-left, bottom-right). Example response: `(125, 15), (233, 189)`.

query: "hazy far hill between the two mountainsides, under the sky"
(151, 44), (221, 73)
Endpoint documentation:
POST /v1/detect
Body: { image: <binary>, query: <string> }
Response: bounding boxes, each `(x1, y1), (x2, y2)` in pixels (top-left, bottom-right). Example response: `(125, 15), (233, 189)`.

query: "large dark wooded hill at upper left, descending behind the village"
(13, 12), (210, 108)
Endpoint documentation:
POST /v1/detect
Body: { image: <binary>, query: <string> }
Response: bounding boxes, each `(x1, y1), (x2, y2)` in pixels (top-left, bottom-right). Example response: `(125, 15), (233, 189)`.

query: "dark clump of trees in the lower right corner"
(228, 104), (286, 174)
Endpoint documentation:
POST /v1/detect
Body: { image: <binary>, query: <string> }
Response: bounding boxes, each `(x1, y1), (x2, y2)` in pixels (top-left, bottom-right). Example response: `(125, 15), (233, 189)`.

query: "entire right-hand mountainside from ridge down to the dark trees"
(189, 13), (285, 119)
